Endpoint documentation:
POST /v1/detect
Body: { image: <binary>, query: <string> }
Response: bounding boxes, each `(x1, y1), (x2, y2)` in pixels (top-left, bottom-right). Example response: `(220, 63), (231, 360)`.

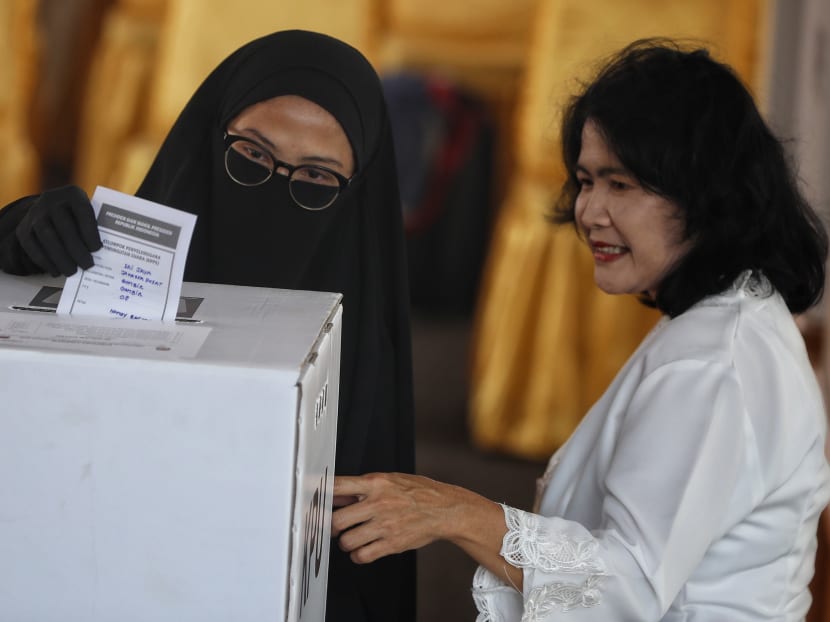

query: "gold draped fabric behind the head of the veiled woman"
(73, 0), (375, 197)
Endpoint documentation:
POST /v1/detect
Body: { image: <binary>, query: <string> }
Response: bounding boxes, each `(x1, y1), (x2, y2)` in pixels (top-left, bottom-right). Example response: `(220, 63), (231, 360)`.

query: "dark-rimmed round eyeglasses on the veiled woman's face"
(225, 133), (351, 211)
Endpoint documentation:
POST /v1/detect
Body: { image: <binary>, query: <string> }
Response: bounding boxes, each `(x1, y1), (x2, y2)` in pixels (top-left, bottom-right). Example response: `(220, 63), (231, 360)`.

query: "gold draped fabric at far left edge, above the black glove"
(0, 0), (40, 206)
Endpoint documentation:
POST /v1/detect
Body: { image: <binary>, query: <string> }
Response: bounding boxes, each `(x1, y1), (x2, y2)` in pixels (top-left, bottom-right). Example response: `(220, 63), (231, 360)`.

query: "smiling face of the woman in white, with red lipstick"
(575, 119), (691, 297)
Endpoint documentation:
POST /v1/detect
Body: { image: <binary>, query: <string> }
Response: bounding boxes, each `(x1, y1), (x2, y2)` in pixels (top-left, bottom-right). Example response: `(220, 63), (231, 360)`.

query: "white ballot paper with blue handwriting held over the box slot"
(57, 186), (196, 321)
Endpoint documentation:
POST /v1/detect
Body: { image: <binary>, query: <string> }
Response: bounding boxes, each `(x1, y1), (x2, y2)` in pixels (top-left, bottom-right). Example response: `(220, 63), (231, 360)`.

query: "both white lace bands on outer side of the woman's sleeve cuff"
(501, 505), (608, 622)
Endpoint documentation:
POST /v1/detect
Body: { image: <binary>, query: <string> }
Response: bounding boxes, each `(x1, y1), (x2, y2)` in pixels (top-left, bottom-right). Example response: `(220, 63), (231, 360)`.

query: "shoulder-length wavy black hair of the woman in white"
(551, 38), (828, 317)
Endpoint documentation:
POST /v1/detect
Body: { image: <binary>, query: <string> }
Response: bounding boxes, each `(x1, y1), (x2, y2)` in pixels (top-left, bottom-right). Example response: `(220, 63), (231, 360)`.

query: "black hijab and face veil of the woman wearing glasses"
(137, 30), (414, 621)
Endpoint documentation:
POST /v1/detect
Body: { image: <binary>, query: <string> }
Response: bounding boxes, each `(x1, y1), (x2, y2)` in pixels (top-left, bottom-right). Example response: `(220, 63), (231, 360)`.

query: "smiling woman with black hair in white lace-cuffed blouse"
(332, 40), (830, 622)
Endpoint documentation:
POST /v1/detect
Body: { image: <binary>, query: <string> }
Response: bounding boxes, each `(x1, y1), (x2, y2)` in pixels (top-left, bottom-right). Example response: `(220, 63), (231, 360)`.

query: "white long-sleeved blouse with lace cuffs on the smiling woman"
(473, 276), (830, 622)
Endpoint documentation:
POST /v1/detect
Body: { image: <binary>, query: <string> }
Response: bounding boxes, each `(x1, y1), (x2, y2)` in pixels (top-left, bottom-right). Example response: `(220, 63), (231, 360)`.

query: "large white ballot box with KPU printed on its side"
(0, 274), (342, 622)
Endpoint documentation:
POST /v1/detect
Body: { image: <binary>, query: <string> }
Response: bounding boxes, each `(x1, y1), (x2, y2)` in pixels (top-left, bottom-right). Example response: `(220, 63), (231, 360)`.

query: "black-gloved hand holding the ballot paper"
(7, 186), (101, 276)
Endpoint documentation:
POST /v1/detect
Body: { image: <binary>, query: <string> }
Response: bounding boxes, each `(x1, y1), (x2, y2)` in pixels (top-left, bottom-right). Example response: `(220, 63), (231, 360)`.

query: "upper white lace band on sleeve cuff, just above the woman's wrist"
(501, 505), (606, 575)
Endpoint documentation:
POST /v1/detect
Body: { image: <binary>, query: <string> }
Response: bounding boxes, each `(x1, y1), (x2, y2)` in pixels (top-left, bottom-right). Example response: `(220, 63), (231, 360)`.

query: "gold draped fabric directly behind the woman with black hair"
(469, 0), (764, 459)
